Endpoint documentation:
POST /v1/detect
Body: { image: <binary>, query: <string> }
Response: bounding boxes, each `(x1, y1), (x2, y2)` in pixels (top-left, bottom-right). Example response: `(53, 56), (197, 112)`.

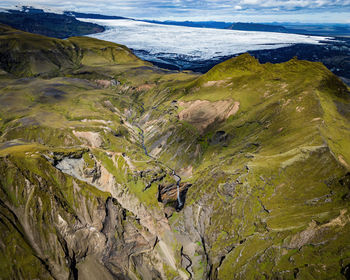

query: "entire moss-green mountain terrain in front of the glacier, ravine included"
(0, 27), (350, 279)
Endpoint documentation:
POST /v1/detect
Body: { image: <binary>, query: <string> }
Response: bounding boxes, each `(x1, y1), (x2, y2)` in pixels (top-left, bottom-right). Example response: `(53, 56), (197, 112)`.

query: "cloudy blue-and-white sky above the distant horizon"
(0, 0), (350, 23)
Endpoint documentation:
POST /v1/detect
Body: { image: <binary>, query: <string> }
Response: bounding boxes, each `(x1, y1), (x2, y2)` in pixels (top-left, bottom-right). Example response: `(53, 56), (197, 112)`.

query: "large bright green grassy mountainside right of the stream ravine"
(137, 55), (350, 279)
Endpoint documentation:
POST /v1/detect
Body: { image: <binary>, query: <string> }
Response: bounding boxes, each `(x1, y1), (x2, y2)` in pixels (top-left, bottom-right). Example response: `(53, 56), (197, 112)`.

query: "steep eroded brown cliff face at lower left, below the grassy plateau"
(0, 152), (180, 279)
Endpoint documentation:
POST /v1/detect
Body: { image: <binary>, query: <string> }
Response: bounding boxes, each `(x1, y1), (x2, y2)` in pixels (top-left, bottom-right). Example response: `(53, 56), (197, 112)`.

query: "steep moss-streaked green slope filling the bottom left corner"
(0, 145), (109, 279)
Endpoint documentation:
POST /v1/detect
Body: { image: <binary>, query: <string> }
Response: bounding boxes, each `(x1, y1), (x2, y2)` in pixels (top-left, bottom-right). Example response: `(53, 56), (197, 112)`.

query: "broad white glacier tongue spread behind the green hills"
(78, 18), (333, 68)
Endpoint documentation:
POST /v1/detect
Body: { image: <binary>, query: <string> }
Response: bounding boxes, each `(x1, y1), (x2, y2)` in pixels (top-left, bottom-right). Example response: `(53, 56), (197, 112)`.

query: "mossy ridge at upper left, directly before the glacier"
(0, 25), (197, 84)
